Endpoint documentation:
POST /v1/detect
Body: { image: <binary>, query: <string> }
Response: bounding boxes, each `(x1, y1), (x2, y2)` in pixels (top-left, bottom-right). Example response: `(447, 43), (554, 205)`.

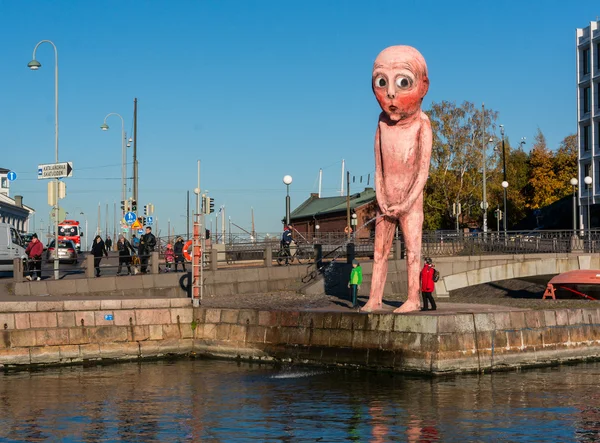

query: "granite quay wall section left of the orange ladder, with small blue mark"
(0, 298), (196, 367)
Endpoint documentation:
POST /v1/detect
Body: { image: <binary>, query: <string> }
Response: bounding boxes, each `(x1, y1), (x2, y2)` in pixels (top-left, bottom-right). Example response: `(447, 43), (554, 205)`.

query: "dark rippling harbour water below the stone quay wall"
(0, 360), (600, 442)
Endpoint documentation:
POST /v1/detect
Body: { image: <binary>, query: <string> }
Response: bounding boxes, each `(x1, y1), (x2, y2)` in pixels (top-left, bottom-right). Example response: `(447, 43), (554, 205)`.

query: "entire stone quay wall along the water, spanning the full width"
(0, 298), (600, 374)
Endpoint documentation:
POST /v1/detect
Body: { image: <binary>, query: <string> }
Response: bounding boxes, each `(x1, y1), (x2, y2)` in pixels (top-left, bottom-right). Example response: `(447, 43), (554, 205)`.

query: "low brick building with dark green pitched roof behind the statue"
(290, 188), (377, 241)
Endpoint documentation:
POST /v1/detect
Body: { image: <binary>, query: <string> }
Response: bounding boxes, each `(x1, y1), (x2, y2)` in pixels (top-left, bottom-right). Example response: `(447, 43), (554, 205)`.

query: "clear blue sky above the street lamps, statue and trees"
(0, 0), (600, 239)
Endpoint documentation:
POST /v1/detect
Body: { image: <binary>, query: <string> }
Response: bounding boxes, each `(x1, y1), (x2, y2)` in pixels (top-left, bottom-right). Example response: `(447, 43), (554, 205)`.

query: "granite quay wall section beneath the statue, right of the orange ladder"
(194, 309), (600, 374)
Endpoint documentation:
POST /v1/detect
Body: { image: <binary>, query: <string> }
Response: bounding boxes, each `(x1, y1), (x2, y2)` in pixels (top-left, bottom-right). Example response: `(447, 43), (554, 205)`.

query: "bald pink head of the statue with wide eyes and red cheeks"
(372, 46), (429, 121)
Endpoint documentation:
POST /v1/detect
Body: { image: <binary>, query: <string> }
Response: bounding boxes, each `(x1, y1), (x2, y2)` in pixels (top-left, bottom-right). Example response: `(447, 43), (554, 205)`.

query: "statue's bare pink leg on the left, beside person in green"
(361, 217), (397, 312)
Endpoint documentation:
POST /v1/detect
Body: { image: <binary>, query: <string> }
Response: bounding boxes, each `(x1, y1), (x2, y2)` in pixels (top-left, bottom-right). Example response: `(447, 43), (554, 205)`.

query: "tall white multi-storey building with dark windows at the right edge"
(576, 21), (600, 228)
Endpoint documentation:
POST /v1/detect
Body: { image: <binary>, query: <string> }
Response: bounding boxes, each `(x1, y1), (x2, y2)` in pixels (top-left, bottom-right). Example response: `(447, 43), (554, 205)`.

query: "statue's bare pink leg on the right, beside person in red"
(394, 196), (423, 313)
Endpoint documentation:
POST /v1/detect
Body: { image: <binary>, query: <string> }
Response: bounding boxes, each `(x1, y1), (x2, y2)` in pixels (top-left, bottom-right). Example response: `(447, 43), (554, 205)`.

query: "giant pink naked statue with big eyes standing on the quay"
(362, 46), (432, 313)
